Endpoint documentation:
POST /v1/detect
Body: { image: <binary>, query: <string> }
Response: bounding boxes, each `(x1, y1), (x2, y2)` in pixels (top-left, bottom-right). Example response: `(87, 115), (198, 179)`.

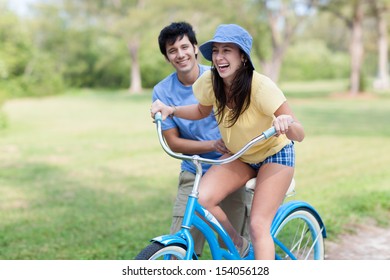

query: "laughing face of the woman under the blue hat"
(212, 43), (244, 83)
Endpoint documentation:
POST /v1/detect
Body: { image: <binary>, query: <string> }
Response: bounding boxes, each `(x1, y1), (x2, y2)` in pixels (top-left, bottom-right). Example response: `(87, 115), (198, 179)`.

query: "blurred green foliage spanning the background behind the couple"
(0, 0), (386, 98)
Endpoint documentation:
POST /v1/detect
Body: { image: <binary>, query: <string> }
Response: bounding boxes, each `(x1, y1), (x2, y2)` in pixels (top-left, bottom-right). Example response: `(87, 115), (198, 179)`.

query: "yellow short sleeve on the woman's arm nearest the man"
(192, 70), (215, 106)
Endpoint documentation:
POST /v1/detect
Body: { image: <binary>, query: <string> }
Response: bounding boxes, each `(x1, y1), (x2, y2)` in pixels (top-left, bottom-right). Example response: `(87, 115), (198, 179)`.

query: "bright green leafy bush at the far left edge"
(0, 4), (64, 99)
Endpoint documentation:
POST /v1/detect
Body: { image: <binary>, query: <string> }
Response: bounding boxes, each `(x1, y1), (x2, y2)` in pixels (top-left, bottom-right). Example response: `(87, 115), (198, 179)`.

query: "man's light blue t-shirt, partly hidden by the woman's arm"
(152, 65), (221, 174)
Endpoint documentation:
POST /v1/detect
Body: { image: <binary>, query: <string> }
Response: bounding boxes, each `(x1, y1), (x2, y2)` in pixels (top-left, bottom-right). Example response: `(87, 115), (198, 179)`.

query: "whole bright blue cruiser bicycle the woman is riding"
(135, 113), (326, 260)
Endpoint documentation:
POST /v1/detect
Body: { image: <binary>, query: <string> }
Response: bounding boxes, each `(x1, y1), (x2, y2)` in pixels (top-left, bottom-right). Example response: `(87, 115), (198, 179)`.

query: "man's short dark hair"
(158, 21), (198, 58)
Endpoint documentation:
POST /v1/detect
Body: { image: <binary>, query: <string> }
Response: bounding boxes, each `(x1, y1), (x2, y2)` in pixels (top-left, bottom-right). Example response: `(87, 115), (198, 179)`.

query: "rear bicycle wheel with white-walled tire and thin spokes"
(274, 207), (325, 260)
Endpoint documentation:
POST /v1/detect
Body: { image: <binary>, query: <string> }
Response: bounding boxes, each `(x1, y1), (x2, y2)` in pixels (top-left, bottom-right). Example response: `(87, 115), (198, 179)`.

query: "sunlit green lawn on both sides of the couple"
(0, 86), (390, 259)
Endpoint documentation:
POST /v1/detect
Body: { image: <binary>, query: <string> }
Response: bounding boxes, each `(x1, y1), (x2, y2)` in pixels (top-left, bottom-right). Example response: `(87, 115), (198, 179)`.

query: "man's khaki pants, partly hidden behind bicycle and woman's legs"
(171, 171), (250, 255)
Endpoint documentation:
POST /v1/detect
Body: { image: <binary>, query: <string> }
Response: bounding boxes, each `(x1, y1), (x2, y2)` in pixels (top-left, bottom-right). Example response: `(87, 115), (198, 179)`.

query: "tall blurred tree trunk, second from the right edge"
(349, 0), (364, 96)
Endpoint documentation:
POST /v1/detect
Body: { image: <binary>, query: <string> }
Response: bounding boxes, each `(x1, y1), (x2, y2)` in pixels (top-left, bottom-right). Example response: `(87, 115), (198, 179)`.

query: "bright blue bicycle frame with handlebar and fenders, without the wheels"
(151, 113), (326, 260)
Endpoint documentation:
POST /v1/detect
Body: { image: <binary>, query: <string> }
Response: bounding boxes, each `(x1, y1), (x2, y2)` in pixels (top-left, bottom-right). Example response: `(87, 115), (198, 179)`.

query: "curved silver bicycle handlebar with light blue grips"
(154, 112), (276, 165)
